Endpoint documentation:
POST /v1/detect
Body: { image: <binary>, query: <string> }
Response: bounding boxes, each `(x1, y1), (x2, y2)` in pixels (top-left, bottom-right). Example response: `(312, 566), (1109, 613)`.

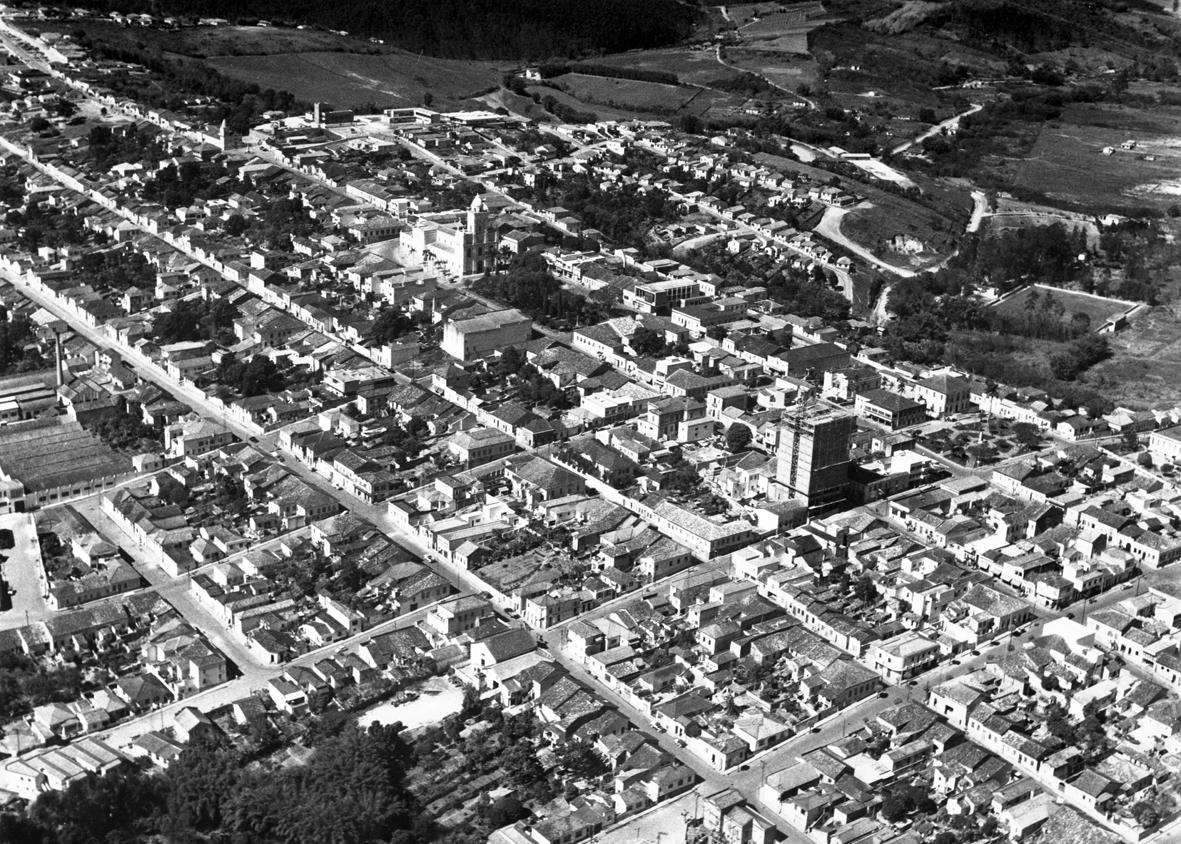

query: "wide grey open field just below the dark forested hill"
(208, 52), (501, 106)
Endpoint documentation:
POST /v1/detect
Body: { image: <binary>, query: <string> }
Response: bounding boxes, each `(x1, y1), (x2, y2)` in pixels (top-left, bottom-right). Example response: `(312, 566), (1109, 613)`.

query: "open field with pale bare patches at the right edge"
(1013, 105), (1181, 211)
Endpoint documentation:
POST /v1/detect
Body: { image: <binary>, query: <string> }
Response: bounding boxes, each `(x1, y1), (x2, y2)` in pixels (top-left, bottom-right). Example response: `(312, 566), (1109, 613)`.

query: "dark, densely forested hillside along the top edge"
(41, 0), (697, 59)
